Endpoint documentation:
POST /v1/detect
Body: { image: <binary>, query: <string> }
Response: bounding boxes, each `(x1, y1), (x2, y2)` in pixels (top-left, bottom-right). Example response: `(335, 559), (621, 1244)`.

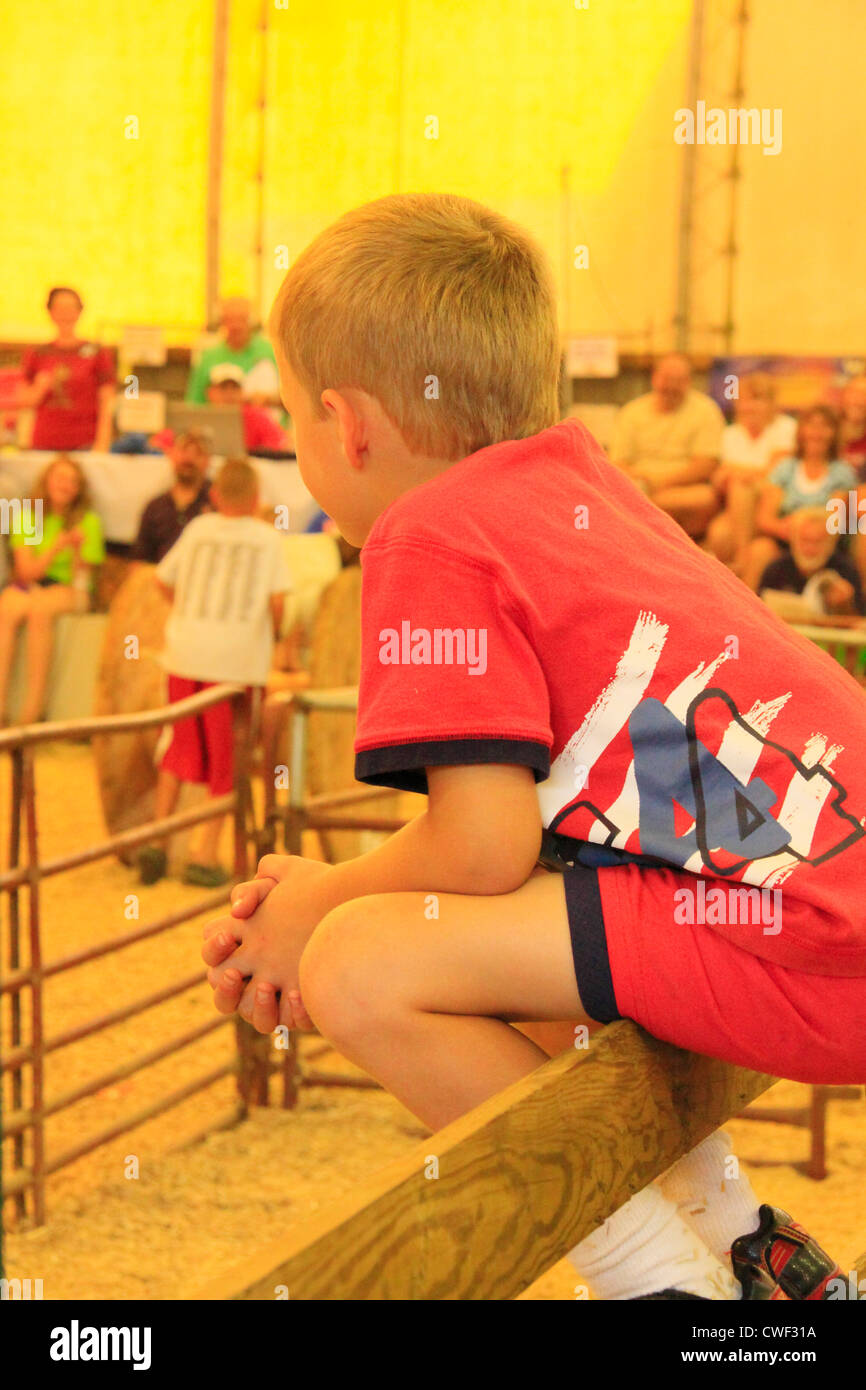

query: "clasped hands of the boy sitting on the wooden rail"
(202, 855), (332, 1033)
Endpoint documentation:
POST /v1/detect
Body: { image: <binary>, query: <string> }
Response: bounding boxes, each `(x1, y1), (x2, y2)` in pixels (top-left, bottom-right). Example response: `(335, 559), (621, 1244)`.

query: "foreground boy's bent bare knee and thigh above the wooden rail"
(296, 873), (591, 1130)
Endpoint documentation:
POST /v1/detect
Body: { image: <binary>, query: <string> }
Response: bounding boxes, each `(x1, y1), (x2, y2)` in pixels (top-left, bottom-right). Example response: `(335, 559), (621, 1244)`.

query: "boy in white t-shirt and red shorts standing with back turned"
(139, 459), (292, 888)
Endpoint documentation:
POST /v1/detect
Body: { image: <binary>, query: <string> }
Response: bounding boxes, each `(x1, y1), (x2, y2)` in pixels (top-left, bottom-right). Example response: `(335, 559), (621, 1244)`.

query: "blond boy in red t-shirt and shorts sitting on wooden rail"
(203, 195), (866, 1300)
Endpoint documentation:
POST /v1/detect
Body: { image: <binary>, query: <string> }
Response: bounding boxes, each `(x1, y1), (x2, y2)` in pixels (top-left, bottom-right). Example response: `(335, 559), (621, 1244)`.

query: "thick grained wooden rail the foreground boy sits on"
(190, 1020), (774, 1300)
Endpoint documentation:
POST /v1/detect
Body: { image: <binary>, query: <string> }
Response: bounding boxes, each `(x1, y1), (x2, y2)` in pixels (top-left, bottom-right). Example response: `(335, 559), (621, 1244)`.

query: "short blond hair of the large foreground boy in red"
(274, 193), (560, 459)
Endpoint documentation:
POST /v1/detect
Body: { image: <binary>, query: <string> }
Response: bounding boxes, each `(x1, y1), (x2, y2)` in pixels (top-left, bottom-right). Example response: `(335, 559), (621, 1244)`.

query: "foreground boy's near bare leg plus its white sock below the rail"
(300, 872), (737, 1300)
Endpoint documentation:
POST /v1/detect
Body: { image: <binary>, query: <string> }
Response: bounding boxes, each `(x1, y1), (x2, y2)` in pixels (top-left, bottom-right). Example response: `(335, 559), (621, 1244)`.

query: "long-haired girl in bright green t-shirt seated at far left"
(0, 455), (106, 724)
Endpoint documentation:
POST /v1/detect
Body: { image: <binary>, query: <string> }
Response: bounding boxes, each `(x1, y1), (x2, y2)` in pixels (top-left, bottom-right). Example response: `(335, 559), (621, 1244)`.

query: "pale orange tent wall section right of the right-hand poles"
(735, 0), (866, 356)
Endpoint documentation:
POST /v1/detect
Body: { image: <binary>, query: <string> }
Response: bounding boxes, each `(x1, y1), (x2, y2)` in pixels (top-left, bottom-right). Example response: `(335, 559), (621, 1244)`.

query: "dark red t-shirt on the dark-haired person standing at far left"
(21, 342), (115, 449)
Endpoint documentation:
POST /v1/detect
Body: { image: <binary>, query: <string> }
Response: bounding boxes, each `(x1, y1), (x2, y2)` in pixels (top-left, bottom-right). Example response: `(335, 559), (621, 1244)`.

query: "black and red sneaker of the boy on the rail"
(731, 1202), (844, 1302)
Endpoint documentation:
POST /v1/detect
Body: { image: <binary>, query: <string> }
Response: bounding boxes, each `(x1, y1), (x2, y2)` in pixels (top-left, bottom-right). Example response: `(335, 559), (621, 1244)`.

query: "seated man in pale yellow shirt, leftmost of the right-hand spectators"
(610, 353), (724, 537)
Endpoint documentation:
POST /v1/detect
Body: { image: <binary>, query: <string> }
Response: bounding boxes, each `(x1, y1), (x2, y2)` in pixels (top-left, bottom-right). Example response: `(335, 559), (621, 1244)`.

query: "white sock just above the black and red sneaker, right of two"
(659, 1130), (760, 1266)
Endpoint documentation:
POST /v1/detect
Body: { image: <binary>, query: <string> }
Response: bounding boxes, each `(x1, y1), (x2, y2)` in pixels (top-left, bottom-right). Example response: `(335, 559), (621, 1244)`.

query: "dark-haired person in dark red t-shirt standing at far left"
(19, 286), (115, 453)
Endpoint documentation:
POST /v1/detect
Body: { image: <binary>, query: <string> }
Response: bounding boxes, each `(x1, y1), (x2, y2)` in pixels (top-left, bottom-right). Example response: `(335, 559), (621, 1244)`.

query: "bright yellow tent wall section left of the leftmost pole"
(0, 0), (213, 341)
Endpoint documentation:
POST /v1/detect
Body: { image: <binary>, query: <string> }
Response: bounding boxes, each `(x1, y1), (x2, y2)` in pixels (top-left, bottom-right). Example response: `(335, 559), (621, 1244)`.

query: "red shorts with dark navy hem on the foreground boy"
(564, 865), (866, 1086)
